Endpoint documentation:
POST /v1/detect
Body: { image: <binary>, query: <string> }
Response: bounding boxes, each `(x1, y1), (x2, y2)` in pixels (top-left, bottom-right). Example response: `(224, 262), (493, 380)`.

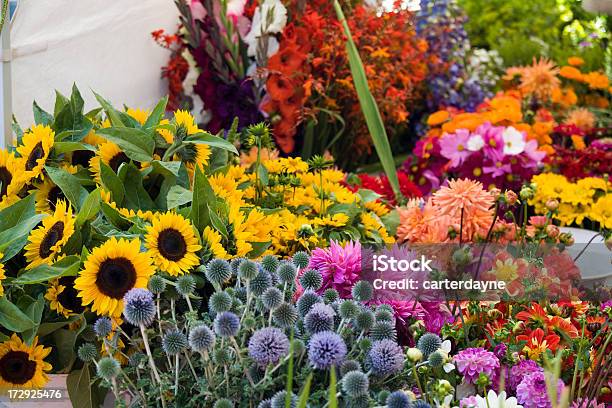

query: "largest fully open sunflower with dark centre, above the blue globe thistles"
(74, 237), (155, 316)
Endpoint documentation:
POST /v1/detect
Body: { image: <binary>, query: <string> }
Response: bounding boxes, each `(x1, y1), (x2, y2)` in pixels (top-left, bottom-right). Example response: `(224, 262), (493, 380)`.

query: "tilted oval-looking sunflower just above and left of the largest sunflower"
(25, 200), (74, 269)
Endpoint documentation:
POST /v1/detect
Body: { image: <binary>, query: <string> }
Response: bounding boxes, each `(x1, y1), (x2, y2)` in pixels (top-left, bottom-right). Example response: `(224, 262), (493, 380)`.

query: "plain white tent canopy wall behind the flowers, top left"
(0, 0), (178, 145)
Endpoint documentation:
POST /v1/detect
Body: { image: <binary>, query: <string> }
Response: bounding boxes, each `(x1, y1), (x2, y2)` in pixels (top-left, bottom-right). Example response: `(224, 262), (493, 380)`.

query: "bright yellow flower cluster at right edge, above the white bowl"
(529, 173), (612, 229)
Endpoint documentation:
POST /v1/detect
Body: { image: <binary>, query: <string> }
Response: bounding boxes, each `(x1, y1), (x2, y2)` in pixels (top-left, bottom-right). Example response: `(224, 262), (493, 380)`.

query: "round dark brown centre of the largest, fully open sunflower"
(96, 258), (136, 299)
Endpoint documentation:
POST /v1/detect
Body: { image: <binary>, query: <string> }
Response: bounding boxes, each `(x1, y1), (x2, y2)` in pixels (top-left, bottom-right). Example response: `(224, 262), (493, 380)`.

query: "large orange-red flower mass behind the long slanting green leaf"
(263, 1), (427, 155)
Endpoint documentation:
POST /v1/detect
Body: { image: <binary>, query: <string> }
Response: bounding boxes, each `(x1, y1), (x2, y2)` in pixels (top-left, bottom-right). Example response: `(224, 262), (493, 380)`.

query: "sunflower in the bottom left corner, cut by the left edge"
(0, 333), (52, 389)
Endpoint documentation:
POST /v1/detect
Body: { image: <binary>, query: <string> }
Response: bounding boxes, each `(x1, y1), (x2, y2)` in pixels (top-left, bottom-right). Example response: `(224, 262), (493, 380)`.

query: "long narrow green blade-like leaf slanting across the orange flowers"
(334, 0), (401, 198)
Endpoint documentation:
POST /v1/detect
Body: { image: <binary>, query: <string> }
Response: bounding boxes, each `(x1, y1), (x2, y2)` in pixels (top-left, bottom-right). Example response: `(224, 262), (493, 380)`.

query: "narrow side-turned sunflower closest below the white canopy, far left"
(17, 125), (55, 178)
